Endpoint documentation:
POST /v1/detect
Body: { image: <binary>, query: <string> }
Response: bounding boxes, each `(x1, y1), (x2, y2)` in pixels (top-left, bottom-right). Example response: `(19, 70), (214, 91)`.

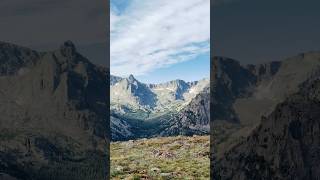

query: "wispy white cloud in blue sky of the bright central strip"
(110, 0), (210, 76)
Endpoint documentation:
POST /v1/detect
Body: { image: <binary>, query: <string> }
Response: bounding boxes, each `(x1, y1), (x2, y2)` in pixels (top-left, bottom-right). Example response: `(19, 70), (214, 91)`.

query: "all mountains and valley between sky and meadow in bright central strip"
(110, 75), (210, 141)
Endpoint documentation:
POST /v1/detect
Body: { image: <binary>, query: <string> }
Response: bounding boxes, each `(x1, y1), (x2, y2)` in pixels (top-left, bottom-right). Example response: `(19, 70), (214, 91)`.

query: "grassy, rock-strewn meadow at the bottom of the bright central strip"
(110, 136), (210, 179)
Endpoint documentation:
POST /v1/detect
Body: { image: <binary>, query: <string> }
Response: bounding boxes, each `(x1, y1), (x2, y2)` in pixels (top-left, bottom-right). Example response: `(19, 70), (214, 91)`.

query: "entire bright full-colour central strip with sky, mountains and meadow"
(110, 0), (210, 179)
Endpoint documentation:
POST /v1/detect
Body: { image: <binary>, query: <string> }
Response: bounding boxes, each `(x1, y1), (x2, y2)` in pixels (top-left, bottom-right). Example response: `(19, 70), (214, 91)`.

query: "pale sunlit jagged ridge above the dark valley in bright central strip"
(110, 75), (209, 112)
